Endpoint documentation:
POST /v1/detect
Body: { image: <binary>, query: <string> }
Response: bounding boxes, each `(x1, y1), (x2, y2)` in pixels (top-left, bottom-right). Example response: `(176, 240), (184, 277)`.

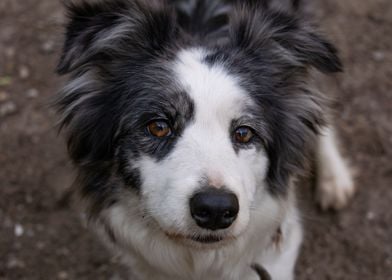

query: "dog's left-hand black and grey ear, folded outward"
(57, 0), (176, 74)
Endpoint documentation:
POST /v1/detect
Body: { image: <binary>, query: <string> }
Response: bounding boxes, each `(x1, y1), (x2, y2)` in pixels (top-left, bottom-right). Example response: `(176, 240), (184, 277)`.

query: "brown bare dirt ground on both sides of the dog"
(0, 0), (392, 280)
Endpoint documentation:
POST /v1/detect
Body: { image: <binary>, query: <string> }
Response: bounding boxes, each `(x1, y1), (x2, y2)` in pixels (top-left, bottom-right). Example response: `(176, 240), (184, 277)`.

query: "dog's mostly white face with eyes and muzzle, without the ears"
(133, 49), (268, 242)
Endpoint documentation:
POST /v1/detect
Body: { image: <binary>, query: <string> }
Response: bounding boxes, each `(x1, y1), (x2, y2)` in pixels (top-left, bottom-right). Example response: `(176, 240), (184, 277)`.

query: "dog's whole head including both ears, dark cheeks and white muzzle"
(57, 0), (340, 247)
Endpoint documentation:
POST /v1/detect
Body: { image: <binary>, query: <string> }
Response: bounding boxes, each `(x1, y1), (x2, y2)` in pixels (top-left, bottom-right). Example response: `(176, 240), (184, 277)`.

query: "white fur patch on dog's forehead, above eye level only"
(173, 49), (251, 120)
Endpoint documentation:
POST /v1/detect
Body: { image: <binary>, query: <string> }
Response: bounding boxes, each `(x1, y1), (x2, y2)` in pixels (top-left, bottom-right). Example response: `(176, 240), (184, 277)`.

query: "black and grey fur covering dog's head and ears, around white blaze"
(56, 0), (341, 216)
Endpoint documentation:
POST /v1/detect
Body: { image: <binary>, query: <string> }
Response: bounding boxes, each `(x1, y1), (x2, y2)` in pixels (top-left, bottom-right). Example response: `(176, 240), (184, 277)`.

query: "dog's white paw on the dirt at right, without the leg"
(317, 168), (355, 210)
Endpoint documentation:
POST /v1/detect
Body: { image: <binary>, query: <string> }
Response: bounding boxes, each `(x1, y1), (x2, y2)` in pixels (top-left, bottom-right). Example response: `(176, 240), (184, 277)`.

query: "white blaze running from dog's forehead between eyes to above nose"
(170, 49), (256, 187)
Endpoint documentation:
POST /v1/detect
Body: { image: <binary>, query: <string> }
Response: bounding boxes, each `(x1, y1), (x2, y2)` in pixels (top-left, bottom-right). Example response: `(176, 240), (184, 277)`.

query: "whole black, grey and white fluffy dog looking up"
(55, 0), (354, 280)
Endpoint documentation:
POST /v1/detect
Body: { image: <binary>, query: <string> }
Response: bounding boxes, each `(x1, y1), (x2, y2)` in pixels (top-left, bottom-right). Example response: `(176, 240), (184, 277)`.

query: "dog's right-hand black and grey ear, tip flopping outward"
(231, 4), (342, 73)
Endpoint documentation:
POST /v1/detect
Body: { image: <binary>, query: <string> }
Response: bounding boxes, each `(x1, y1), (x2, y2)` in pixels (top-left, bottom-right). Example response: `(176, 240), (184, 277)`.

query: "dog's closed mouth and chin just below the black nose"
(165, 232), (236, 249)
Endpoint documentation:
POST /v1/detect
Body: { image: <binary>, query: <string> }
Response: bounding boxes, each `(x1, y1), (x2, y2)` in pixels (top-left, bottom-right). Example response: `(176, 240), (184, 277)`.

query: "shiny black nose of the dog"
(190, 188), (240, 230)
